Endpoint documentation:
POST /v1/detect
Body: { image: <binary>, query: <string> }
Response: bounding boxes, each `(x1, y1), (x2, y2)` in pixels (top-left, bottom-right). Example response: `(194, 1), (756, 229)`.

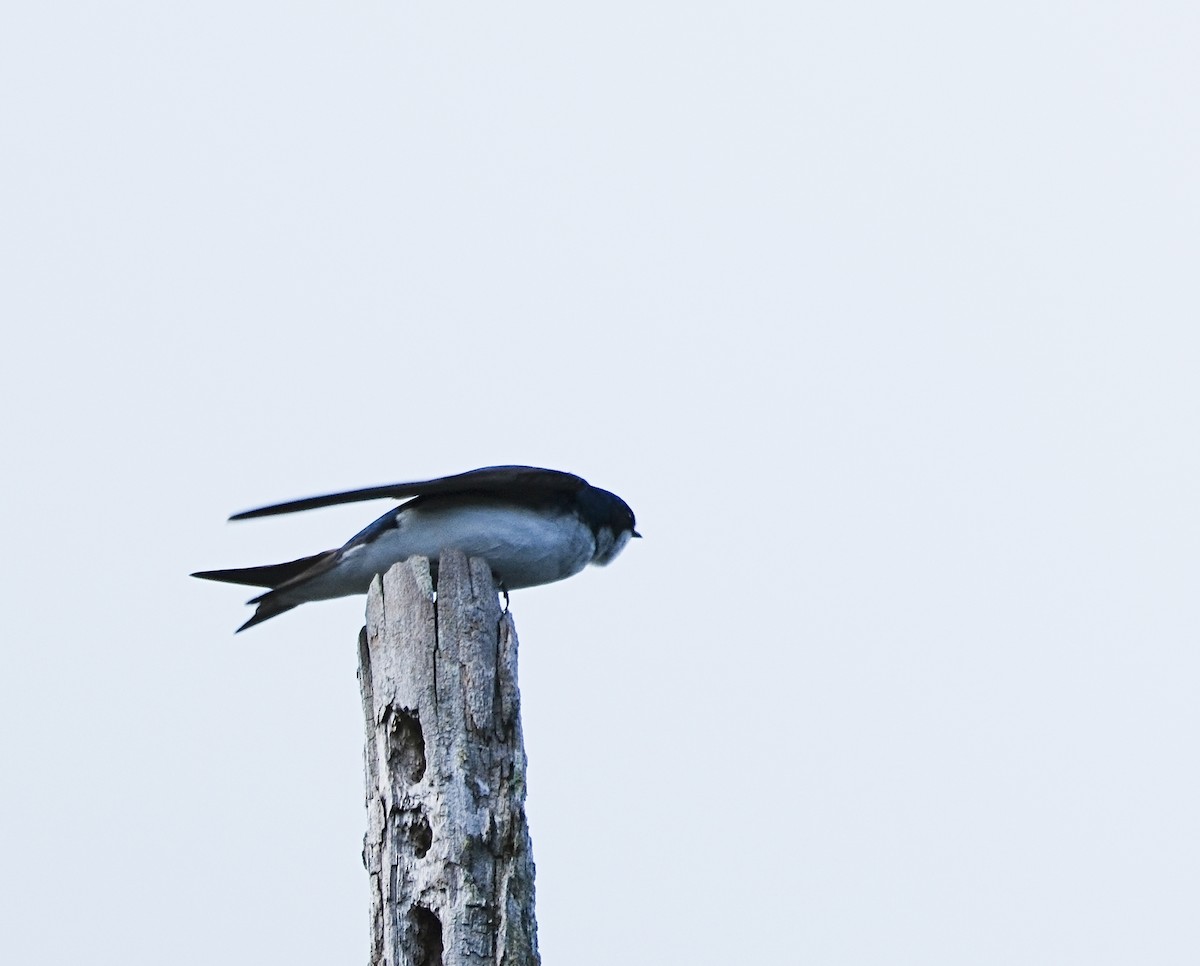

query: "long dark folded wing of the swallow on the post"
(229, 467), (588, 520)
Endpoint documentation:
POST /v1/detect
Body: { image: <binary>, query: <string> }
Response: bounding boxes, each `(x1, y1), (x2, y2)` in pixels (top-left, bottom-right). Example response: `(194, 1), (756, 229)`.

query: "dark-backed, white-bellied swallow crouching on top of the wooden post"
(191, 466), (641, 632)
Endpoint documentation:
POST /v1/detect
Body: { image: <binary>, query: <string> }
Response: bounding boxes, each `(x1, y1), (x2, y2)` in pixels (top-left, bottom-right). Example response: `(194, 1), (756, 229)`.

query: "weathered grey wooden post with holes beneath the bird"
(359, 552), (541, 966)
